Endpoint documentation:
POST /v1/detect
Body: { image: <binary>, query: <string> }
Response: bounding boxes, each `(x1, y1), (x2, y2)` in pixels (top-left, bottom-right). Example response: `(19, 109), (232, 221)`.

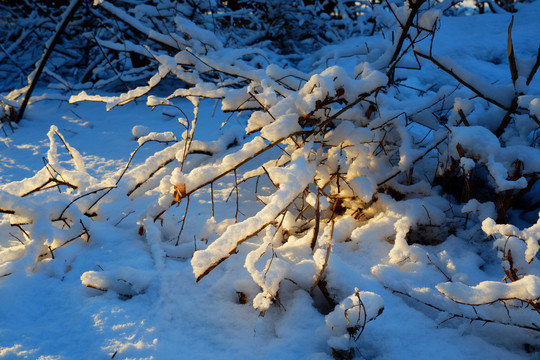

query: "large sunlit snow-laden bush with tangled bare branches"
(0, 0), (540, 351)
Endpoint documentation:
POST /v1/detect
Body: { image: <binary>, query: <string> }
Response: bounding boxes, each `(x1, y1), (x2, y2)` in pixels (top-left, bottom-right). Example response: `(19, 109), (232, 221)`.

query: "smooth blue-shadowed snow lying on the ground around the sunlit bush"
(0, 97), (527, 359)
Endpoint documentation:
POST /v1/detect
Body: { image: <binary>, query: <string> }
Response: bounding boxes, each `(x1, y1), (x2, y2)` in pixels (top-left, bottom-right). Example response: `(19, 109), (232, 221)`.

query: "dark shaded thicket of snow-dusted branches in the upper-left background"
(0, 0), (368, 99)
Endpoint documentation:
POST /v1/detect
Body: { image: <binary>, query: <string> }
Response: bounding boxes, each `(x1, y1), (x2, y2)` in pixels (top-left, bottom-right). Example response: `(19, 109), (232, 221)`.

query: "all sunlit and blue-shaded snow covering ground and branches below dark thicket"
(0, 0), (540, 360)
